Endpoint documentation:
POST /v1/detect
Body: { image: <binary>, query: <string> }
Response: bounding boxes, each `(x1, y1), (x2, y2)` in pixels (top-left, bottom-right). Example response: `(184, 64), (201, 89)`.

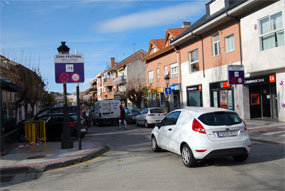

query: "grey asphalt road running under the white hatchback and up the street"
(1, 126), (285, 191)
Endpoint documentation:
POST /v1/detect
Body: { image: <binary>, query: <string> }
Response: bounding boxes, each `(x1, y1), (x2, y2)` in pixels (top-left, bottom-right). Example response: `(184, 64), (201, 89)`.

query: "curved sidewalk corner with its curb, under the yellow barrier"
(0, 139), (109, 175)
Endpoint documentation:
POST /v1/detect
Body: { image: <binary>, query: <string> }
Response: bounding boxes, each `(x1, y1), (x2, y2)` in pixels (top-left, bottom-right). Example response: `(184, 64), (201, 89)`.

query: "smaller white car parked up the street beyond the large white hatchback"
(136, 107), (167, 127)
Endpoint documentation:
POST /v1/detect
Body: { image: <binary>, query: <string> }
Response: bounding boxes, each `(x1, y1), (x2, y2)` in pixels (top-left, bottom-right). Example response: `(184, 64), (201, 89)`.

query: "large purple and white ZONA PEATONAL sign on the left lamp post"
(54, 54), (84, 83)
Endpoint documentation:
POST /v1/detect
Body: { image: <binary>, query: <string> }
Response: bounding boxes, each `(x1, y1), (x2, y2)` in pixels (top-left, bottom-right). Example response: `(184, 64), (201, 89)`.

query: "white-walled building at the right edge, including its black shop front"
(240, 0), (285, 121)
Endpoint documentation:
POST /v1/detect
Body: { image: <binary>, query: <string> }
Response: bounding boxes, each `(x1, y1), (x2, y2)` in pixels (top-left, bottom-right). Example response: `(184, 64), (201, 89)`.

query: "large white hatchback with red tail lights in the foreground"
(151, 107), (251, 167)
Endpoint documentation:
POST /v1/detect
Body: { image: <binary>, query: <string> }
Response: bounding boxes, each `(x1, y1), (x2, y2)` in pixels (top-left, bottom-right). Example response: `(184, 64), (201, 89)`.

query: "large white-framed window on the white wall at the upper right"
(259, 12), (284, 50)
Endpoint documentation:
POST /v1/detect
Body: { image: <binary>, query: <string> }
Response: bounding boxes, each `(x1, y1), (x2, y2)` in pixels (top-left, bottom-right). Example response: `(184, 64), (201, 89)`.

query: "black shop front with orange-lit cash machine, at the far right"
(244, 74), (278, 119)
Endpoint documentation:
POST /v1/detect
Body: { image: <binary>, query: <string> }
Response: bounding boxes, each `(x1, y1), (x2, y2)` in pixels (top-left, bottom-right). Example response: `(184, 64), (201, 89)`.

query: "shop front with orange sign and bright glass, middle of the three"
(210, 81), (234, 110)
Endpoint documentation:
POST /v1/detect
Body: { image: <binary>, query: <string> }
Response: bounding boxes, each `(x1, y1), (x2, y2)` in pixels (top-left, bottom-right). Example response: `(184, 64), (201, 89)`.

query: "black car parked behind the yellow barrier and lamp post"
(17, 113), (87, 142)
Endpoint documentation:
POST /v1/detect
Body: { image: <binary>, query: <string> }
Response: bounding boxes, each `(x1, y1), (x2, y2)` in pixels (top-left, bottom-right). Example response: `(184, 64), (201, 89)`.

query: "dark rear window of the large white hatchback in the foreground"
(198, 112), (242, 126)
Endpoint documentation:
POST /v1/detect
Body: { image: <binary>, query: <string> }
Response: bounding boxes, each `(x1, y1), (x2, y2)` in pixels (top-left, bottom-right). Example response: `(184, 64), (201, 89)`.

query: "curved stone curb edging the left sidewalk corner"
(0, 145), (110, 176)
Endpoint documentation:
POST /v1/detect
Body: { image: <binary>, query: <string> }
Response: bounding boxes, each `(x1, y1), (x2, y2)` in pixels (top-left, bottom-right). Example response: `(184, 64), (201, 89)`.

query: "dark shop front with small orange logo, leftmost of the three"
(186, 84), (203, 107)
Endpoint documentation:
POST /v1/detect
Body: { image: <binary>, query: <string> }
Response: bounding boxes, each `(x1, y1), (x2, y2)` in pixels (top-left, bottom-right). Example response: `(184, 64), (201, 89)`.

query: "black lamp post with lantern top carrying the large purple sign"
(57, 42), (73, 149)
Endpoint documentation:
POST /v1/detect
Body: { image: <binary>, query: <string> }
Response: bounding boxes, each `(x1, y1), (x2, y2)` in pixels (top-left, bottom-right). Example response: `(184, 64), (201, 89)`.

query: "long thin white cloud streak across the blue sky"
(98, 1), (205, 32)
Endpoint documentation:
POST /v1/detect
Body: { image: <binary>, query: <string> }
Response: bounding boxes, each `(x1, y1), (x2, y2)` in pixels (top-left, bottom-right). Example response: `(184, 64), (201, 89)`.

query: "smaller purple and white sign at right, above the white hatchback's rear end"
(228, 65), (244, 84)
